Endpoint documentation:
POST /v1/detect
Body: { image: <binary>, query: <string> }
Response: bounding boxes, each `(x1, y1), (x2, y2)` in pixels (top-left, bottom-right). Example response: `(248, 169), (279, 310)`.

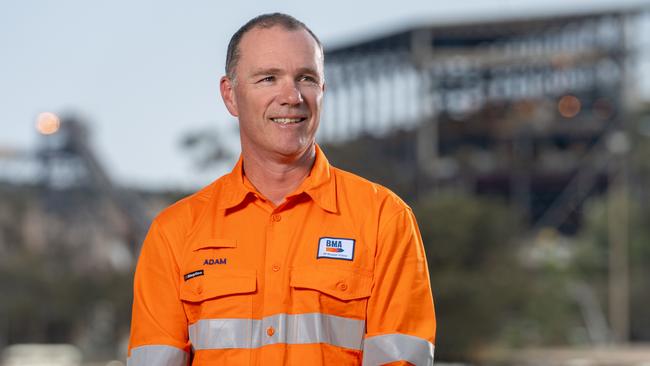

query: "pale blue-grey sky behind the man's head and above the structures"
(0, 0), (650, 189)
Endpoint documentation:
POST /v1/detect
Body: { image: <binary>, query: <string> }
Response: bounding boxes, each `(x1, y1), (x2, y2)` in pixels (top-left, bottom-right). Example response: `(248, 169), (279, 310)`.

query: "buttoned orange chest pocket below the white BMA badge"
(290, 267), (372, 319)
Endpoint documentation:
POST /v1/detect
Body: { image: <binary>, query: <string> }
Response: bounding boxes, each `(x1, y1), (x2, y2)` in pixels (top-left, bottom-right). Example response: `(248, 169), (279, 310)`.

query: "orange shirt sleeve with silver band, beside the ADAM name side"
(127, 220), (190, 366)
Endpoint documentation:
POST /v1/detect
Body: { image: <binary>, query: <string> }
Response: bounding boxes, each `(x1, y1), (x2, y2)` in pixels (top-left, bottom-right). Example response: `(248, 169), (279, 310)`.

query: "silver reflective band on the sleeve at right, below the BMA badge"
(363, 333), (434, 366)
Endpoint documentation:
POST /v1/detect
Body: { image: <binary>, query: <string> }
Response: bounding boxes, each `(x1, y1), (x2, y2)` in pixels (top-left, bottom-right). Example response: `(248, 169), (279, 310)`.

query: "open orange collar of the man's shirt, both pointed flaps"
(217, 145), (337, 212)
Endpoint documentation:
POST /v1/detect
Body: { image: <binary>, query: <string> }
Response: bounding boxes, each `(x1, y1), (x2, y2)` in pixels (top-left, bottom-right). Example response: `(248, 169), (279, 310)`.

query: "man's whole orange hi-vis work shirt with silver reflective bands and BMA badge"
(127, 147), (436, 366)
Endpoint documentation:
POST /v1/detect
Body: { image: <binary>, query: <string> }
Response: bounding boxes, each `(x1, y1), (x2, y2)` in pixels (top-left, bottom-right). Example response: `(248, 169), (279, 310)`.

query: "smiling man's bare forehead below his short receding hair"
(237, 26), (323, 71)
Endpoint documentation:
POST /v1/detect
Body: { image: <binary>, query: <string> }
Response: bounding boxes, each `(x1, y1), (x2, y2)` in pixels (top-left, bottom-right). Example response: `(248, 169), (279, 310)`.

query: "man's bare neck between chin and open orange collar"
(242, 145), (316, 206)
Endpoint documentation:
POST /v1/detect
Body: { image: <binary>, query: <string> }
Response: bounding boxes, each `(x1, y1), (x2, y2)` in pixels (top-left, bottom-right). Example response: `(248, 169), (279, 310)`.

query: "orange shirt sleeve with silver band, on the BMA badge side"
(363, 208), (436, 366)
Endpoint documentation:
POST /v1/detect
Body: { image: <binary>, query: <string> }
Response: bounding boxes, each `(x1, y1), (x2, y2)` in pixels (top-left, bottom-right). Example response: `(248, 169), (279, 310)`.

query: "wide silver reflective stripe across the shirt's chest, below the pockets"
(189, 313), (365, 350)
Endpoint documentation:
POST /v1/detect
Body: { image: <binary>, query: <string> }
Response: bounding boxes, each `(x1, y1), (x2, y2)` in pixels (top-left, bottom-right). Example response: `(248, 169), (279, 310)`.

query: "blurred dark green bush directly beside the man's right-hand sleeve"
(414, 194), (524, 360)
